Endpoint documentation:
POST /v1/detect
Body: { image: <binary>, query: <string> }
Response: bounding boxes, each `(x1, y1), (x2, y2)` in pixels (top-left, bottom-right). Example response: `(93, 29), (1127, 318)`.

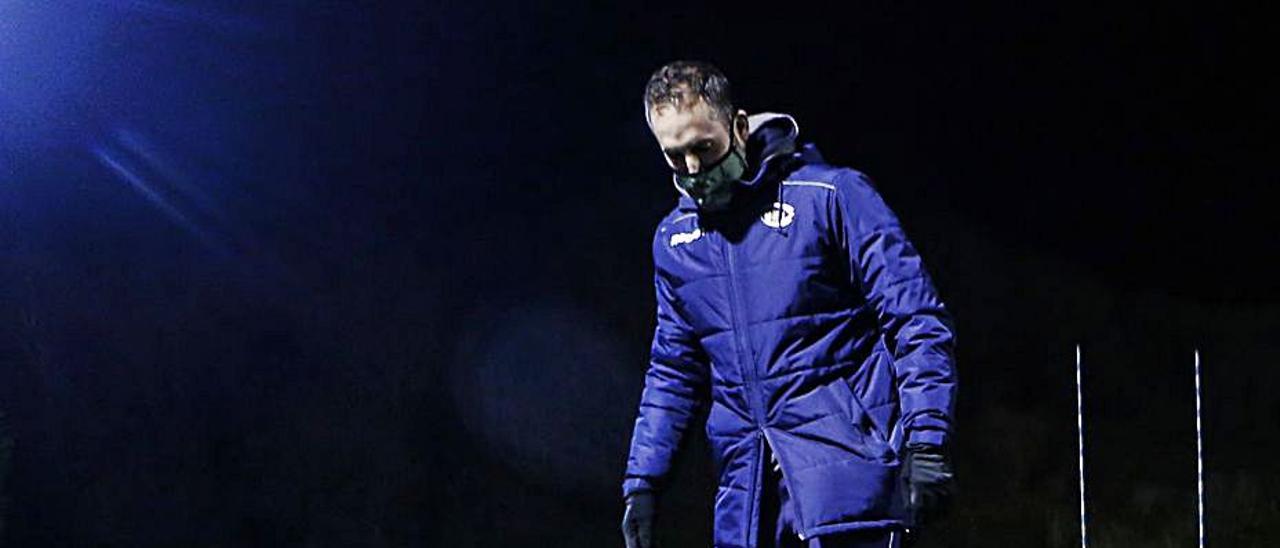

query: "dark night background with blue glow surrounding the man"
(0, 1), (1280, 547)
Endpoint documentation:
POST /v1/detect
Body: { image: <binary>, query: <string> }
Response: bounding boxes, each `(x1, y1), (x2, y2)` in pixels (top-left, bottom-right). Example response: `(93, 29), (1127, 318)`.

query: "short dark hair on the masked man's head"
(644, 60), (733, 124)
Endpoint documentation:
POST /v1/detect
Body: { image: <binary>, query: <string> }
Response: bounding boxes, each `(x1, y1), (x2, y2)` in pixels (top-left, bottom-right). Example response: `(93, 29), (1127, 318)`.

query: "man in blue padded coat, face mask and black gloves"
(622, 61), (956, 548)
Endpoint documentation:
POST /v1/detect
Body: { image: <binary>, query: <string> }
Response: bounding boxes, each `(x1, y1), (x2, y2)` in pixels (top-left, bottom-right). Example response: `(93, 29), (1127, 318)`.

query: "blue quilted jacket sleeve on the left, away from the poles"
(622, 267), (710, 497)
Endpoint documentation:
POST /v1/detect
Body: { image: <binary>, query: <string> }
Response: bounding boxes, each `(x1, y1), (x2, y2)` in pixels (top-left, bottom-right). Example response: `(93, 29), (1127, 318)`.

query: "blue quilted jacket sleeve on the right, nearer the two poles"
(835, 170), (957, 444)
